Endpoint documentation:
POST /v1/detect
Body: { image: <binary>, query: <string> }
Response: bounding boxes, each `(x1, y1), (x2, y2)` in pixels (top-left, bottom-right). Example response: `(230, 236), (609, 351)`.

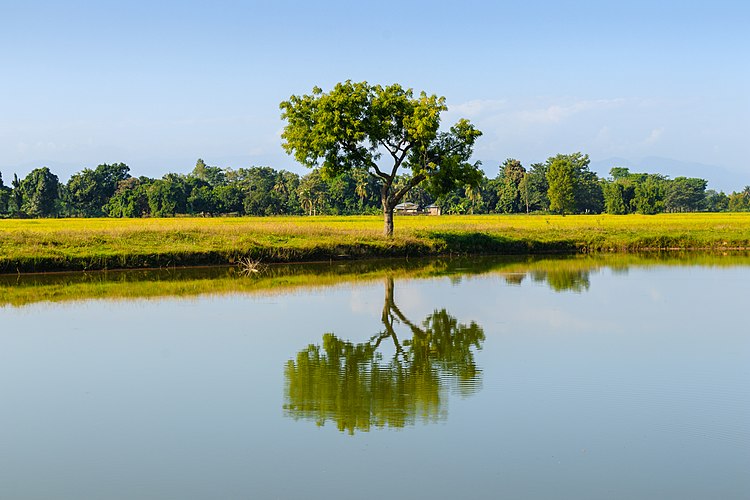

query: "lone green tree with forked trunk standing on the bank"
(279, 80), (482, 236)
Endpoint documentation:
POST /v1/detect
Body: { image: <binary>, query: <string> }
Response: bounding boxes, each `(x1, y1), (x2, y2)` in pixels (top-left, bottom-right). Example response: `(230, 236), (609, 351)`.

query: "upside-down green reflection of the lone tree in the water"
(284, 278), (484, 434)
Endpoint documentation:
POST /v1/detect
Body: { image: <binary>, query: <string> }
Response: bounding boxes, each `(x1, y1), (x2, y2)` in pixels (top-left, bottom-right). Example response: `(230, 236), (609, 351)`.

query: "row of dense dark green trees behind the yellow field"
(0, 153), (750, 217)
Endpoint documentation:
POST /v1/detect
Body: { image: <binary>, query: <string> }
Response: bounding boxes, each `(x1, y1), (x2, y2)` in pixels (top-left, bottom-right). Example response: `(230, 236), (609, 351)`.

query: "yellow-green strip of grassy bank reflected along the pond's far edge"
(0, 252), (750, 306)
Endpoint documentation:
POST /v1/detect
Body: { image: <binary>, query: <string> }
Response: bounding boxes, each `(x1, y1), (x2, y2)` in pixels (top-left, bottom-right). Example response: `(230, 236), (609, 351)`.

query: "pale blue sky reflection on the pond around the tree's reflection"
(0, 267), (750, 498)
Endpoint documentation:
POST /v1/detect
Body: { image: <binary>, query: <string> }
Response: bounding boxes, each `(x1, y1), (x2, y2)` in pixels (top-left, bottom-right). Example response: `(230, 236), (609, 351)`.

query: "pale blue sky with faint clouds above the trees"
(0, 0), (750, 191)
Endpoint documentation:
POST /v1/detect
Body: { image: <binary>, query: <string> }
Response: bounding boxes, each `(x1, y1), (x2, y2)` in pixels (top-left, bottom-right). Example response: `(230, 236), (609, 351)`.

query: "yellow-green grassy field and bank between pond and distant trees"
(0, 214), (750, 273)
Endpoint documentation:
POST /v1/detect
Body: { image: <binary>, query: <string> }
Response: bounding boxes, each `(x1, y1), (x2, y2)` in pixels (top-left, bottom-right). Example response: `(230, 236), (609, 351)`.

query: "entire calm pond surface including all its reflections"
(0, 256), (750, 499)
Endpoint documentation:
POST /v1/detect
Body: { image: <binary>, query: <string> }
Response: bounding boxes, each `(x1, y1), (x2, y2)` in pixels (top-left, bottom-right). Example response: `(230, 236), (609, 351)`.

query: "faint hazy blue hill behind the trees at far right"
(591, 156), (750, 194)
